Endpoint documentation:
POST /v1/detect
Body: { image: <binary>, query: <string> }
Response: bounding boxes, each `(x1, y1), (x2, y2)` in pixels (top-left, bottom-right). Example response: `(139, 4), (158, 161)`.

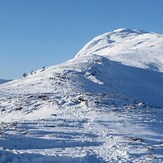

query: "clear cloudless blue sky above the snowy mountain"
(0, 0), (163, 79)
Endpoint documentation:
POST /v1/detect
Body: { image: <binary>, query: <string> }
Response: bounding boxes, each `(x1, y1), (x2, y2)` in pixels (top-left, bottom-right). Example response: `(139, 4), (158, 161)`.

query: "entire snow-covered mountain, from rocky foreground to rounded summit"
(0, 29), (163, 162)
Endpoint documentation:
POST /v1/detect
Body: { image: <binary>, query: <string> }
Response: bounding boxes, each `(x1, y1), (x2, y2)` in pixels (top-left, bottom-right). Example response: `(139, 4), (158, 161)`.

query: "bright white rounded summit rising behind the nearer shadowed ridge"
(76, 29), (163, 72)
